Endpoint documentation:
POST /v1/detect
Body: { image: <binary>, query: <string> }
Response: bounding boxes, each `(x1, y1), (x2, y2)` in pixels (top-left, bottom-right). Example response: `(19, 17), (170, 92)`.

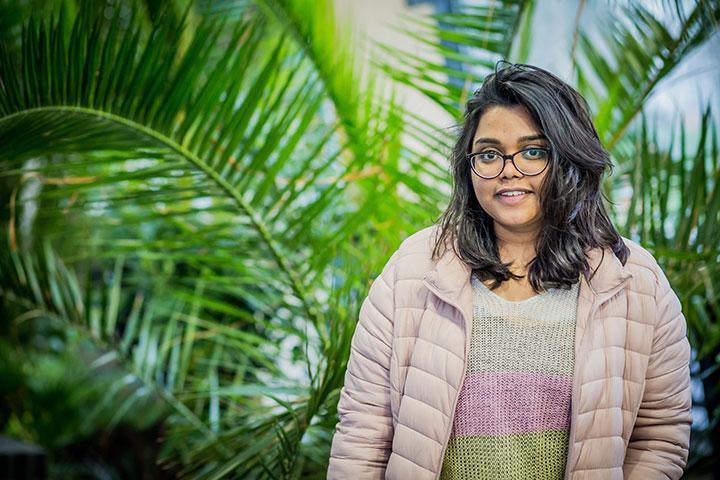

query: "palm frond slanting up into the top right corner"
(576, 0), (720, 149)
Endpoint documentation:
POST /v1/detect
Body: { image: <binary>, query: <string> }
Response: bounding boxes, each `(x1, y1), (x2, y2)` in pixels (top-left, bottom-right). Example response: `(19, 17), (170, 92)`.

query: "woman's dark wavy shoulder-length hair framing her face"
(433, 61), (630, 292)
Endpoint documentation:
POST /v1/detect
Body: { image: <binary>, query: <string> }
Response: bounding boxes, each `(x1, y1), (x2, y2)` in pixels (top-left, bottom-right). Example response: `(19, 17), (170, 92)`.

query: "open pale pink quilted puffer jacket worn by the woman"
(328, 225), (692, 480)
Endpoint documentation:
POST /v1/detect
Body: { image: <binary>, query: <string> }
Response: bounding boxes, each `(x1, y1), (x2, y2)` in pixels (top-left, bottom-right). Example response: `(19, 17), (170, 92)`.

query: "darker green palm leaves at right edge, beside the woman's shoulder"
(611, 101), (720, 470)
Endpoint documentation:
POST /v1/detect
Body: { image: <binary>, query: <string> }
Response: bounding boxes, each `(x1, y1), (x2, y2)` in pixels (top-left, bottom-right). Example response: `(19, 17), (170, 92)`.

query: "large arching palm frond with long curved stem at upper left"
(0, 7), (334, 332)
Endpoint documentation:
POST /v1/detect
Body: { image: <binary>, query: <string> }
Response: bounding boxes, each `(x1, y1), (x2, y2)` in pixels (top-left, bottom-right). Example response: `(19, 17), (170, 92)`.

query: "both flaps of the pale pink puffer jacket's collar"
(424, 240), (632, 299)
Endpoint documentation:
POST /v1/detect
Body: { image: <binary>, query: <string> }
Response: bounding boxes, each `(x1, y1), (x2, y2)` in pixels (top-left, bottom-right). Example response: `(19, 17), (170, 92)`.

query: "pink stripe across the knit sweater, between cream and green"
(453, 372), (572, 437)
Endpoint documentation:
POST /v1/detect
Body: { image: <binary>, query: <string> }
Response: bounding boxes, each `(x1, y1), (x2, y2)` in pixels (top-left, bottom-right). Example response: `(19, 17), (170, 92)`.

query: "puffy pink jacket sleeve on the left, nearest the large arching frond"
(327, 252), (398, 480)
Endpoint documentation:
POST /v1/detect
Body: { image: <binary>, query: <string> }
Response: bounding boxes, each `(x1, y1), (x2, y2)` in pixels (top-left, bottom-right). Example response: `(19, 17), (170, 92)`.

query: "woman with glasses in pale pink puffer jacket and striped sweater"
(328, 65), (692, 480)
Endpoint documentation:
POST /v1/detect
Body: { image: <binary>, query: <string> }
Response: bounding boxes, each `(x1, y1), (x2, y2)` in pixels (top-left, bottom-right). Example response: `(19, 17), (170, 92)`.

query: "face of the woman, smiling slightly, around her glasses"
(468, 106), (550, 238)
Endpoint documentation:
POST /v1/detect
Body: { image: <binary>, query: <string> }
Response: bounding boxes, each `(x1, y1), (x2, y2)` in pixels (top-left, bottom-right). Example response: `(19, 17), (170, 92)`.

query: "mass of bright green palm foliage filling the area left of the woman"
(0, 0), (439, 478)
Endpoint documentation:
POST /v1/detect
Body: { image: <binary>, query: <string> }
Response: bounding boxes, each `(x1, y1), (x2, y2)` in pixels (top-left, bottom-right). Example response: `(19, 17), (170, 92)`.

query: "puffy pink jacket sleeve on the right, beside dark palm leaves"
(623, 264), (692, 480)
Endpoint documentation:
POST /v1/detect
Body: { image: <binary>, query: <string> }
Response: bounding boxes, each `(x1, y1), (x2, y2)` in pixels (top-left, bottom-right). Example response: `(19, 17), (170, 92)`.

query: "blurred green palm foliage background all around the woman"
(0, 0), (720, 479)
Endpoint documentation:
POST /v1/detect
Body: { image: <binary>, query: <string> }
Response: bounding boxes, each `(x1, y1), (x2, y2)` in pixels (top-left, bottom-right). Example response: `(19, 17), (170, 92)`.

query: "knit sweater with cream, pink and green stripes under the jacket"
(440, 275), (579, 480)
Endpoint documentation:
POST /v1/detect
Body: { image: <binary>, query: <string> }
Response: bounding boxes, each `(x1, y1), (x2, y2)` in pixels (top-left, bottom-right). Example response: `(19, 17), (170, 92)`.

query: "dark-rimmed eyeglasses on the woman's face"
(467, 147), (550, 180)
